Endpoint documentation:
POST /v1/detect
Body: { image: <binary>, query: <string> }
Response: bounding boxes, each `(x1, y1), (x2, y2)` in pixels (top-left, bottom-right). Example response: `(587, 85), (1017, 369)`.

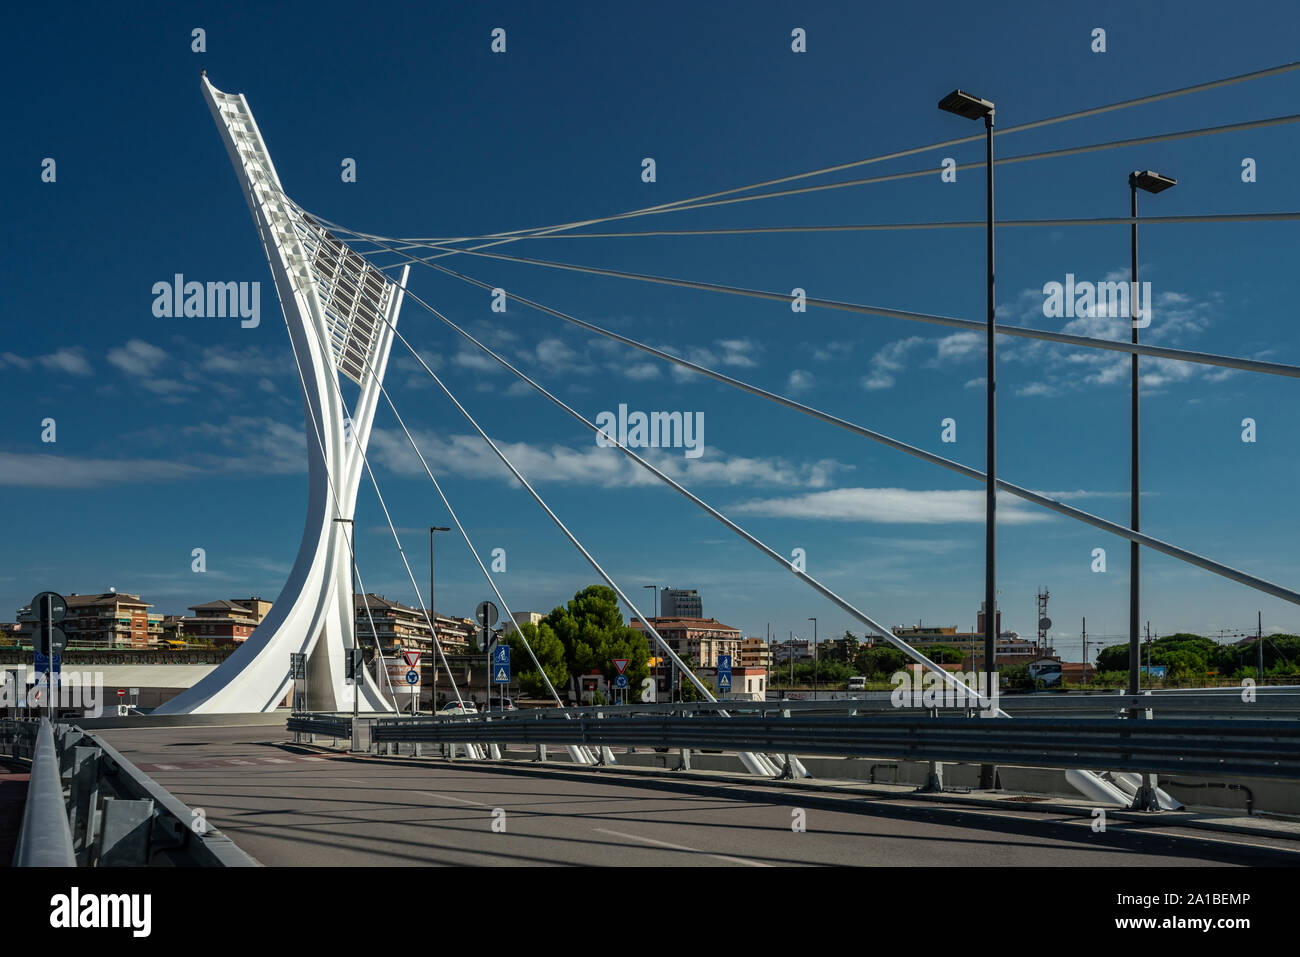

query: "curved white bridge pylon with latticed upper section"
(157, 77), (410, 714)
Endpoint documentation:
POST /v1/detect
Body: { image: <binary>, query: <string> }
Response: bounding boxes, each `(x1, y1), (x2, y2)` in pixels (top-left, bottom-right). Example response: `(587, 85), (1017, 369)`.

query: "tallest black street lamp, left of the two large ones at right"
(939, 90), (997, 712)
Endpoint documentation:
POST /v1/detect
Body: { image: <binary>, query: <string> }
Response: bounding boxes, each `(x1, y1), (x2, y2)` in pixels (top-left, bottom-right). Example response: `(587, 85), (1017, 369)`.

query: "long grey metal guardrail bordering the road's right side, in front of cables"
(372, 702), (1300, 779)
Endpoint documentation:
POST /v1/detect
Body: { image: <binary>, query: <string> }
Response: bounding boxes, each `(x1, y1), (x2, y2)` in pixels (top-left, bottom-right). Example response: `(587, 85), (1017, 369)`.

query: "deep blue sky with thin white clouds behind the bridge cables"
(0, 3), (1300, 657)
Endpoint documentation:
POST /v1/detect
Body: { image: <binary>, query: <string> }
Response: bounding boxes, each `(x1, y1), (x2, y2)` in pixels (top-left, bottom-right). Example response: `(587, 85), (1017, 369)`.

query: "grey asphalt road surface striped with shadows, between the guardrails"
(101, 727), (1300, 867)
